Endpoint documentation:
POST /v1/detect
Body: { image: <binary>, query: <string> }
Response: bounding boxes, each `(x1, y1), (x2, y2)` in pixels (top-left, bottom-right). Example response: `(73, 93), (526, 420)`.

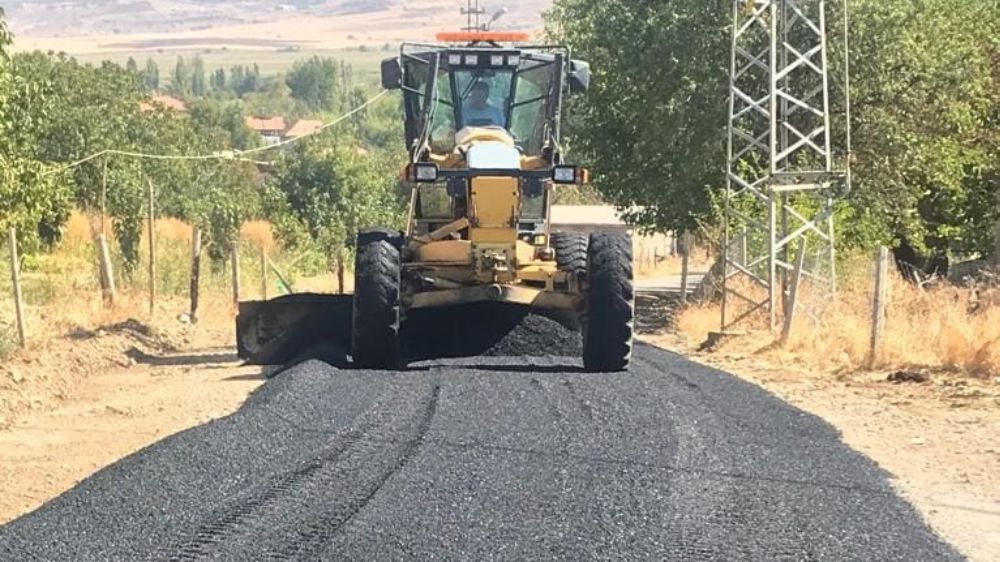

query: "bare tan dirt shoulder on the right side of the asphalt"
(648, 335), (1000, 562)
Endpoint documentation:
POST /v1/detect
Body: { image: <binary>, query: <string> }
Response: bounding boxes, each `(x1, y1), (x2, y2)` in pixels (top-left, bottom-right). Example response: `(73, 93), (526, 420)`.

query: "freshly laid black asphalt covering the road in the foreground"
(0, 310), (962, 561)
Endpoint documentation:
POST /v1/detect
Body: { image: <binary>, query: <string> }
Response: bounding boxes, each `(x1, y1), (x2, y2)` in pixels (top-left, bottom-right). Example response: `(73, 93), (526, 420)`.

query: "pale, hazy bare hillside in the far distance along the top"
(4, 0), (552, 48)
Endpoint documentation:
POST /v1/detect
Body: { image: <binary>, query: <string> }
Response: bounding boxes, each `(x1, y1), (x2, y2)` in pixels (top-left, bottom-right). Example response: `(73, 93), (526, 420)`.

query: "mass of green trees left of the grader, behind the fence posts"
(0, 5), (403, 273)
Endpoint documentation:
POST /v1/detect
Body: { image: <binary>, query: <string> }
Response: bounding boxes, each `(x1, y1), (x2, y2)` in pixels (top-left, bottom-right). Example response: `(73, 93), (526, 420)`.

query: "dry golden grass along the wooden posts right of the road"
(677, 260), (1000, 377)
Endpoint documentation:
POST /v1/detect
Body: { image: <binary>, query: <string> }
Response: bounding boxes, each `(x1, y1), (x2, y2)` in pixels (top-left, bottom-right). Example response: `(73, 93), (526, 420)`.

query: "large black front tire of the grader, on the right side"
(583, 233), (635, 372)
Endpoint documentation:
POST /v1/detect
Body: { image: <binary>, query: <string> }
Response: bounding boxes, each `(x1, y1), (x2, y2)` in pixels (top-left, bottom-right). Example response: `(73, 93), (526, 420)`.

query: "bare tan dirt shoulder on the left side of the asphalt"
(0, 300), (264, 524)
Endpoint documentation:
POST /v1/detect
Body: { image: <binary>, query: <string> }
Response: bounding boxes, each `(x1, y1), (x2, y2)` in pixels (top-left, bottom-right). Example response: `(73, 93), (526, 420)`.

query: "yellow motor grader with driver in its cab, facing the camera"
(234, 32), (634, 371)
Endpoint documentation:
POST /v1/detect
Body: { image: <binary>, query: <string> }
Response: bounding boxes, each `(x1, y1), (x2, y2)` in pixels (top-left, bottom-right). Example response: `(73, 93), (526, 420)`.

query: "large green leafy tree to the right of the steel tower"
(835, 0), (1000, 255)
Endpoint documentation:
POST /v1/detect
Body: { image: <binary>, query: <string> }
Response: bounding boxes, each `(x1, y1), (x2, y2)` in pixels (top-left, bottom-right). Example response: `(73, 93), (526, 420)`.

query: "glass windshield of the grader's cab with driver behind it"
(404, 49), (559, 156)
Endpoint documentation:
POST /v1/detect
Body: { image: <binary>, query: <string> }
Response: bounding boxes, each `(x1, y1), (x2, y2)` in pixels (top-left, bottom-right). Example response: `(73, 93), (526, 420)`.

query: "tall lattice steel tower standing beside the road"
(722, 0), (850, 333)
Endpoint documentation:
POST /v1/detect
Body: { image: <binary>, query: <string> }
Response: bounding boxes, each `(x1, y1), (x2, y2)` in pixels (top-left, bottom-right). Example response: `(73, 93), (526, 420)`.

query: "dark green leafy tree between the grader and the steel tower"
(548, 0), (732, 230)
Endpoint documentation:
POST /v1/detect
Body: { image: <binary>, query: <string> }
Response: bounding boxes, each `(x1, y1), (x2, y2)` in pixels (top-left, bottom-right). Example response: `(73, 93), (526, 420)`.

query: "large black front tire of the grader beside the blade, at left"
(351, 231), (402, 369)
